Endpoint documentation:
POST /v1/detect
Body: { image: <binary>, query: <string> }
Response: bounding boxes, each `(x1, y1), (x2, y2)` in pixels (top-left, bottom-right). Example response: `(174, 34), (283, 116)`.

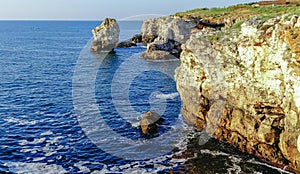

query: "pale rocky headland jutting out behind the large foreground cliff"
(136, 16), (196, 59)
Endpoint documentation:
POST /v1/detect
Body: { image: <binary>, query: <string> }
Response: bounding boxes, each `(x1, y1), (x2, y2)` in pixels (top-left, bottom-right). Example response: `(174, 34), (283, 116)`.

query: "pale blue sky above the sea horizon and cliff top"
(0, 0), (254, 20)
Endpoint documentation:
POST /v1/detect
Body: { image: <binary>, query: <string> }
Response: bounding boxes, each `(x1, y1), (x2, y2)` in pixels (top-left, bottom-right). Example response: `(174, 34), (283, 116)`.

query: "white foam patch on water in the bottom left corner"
(4, 162), (67, 174)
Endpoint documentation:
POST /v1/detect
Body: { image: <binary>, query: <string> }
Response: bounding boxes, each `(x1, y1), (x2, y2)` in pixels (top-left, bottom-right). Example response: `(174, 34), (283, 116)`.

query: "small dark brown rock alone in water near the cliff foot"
(140, 111), (162, 134)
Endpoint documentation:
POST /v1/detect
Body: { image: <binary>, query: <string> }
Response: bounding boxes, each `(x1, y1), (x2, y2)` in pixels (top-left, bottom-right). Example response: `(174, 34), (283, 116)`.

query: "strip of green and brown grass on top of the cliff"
(175, 3), (300, 21)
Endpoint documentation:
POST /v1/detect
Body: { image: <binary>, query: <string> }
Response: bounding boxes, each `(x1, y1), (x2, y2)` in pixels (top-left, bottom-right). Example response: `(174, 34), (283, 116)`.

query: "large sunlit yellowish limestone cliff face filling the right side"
(175, 16), (300, 171)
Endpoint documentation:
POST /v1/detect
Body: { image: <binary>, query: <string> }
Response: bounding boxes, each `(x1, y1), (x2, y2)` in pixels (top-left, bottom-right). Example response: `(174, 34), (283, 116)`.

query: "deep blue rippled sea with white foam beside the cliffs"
(0, 21), (289, 174)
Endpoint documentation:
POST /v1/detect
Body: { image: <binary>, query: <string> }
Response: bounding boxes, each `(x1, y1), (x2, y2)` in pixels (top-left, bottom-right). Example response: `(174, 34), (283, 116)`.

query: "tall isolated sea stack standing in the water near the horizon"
(91, 18), (120, 52)
